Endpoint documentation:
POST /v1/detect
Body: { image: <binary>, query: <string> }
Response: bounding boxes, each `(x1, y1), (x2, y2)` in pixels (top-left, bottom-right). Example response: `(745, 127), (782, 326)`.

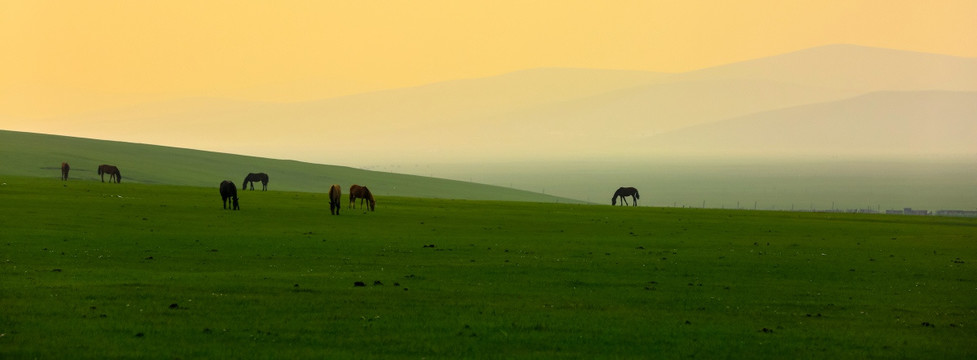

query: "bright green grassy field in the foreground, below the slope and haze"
(0, 176), (977, 359)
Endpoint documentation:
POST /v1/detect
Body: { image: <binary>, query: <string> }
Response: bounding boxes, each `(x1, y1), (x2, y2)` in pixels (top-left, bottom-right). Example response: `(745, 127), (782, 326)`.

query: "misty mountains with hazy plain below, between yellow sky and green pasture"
(4, 45), (977, 210)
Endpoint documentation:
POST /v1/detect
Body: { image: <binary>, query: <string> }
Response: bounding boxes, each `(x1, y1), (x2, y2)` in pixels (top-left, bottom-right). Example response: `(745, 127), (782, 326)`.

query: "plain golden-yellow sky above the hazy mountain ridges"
(0, 0), (977, 117)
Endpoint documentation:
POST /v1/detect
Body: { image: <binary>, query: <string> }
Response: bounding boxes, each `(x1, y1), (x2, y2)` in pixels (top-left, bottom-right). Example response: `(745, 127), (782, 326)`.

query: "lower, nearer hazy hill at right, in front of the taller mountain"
(645, 91), (977, 155)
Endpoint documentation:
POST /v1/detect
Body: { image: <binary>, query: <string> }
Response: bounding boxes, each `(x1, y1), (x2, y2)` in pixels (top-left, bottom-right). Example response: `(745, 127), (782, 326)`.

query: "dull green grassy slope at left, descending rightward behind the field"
(0, 130), (579, 202)
